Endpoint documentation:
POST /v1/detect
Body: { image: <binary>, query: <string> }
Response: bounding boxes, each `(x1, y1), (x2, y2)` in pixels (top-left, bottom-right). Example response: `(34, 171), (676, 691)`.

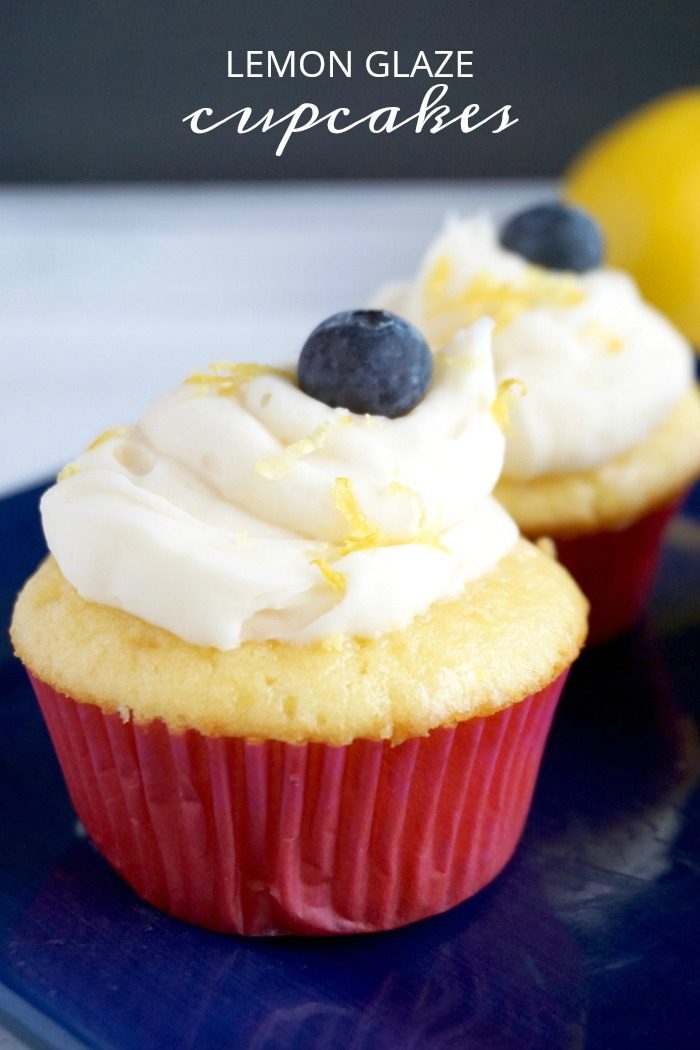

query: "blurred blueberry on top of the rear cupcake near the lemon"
(501, 202), (603, 273)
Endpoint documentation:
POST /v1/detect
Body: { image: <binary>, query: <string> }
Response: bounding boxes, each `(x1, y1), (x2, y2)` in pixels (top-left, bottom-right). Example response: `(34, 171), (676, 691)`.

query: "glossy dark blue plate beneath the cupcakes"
(0, 490), (700, 1050)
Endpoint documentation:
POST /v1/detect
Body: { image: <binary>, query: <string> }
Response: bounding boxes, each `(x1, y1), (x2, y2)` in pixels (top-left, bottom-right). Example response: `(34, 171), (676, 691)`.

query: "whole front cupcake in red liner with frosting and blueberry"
(12, 311), (587, 935)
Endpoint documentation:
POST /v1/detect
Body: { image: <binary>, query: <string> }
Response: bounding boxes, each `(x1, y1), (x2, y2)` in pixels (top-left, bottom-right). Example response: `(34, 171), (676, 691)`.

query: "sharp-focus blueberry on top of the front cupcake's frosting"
(298, 310), (432, 419)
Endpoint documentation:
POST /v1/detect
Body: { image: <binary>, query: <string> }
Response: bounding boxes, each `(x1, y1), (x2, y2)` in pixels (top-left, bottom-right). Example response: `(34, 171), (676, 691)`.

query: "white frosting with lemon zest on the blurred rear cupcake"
(375, 216), (693, 479)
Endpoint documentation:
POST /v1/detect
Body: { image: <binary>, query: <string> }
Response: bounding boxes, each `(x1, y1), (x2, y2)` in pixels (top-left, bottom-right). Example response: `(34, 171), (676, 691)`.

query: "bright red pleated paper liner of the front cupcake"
(25, 672), (566, 936)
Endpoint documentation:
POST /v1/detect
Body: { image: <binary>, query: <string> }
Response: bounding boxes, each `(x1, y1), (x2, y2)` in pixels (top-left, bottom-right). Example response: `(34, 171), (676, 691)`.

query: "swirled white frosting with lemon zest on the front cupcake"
(42, 321), (517, 649)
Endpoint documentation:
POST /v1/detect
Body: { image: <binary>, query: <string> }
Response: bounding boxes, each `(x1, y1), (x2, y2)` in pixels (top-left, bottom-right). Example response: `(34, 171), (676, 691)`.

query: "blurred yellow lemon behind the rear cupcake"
(565, 87), (700, 348)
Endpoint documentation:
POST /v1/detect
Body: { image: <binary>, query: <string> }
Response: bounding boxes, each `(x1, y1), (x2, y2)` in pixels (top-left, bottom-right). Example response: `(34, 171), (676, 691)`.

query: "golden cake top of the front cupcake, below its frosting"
(12, 540), (587, 744)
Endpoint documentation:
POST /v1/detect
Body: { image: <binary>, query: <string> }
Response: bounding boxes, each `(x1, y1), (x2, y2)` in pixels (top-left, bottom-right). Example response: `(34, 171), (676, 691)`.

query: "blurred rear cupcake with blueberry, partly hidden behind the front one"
(377, 204), (700, 642)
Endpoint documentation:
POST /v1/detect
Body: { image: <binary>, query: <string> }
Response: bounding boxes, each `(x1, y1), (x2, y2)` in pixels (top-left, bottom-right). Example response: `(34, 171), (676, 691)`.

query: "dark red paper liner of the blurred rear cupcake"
(556, 499), (682, 645)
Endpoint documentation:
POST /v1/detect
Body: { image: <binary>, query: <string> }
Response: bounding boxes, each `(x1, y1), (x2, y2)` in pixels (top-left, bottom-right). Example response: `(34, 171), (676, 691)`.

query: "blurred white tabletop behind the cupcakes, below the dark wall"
(0, 181), (553, 494)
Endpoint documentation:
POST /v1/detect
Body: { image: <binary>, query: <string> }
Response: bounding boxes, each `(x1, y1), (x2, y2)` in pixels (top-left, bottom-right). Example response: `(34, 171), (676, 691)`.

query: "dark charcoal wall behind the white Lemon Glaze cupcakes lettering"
(5, 0), (700, 182)
